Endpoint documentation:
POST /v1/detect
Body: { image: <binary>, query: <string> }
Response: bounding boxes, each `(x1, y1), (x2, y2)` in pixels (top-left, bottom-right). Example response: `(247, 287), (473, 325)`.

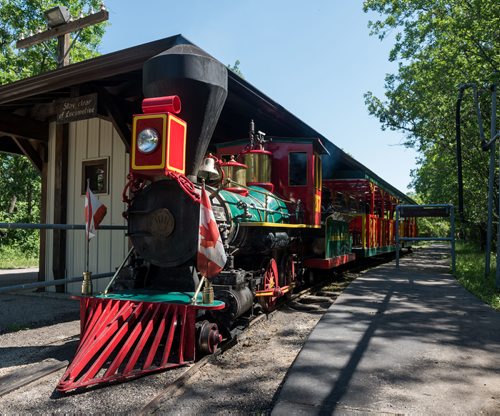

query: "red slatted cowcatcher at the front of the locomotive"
(56, 298), (196, 392)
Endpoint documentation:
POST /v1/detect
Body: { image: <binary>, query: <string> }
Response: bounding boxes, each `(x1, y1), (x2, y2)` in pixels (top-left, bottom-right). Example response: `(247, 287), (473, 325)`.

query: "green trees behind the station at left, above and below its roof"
(0, 0), (105, 257)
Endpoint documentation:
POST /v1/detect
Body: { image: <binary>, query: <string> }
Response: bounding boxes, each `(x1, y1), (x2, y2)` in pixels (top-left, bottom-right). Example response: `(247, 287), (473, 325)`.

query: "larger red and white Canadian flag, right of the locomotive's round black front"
(197, 186), (227, 278)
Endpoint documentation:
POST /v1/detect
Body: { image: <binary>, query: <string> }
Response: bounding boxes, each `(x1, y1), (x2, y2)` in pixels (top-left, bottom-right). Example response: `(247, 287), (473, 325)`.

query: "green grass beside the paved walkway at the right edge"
(455, 243), (500, 310)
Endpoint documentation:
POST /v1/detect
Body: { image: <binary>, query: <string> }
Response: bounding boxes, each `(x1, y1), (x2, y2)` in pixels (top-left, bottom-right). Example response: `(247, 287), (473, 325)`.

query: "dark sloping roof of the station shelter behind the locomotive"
(0, 35), (413, 203)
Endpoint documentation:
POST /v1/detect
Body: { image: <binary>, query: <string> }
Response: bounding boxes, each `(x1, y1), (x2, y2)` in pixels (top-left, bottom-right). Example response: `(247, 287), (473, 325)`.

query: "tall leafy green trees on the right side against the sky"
(364, 0), (500, 232)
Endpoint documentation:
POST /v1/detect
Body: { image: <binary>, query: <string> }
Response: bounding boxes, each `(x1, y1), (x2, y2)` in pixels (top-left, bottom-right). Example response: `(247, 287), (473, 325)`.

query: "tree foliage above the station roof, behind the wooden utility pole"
(0, 0), (105, 85)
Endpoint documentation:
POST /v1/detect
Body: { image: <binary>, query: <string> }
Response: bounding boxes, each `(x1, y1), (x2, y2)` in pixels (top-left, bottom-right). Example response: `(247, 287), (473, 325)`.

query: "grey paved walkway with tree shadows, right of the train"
(272, 248), (500, 416)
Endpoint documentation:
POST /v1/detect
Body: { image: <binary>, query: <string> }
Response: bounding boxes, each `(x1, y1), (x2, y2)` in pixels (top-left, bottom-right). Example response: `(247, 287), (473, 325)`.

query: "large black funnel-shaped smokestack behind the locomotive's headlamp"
(142, 45), (227, 180)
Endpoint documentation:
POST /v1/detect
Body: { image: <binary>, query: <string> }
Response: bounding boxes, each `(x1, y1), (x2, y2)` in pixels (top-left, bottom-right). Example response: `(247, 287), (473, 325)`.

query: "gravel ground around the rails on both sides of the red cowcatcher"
(0, 300), (334, 415)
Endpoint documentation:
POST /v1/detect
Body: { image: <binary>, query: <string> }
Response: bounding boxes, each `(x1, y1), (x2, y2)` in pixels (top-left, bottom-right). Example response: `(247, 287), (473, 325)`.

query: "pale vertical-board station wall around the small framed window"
(45, 118), (129, 294)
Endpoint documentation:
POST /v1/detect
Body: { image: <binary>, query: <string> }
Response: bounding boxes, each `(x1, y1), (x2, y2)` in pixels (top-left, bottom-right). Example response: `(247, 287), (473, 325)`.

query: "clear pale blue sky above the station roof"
(101, 0), (416, 192)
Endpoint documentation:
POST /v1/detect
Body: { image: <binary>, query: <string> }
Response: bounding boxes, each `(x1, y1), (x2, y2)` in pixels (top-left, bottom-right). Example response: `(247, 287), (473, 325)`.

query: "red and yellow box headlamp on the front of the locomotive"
(130, 95), (187, 177)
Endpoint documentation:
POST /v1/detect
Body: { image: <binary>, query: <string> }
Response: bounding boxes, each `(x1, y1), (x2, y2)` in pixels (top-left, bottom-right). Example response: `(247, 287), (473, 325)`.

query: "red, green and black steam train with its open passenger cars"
(57, 45), (417, 392)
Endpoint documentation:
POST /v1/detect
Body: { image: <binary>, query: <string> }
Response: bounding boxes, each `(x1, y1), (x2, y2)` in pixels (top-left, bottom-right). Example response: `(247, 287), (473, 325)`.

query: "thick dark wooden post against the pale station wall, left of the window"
(52, 124), (69, 292)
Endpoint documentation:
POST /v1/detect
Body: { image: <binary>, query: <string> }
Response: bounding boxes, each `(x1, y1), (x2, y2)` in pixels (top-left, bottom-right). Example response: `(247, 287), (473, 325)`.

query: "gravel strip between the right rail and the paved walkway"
(150, 308), (321, 415)
